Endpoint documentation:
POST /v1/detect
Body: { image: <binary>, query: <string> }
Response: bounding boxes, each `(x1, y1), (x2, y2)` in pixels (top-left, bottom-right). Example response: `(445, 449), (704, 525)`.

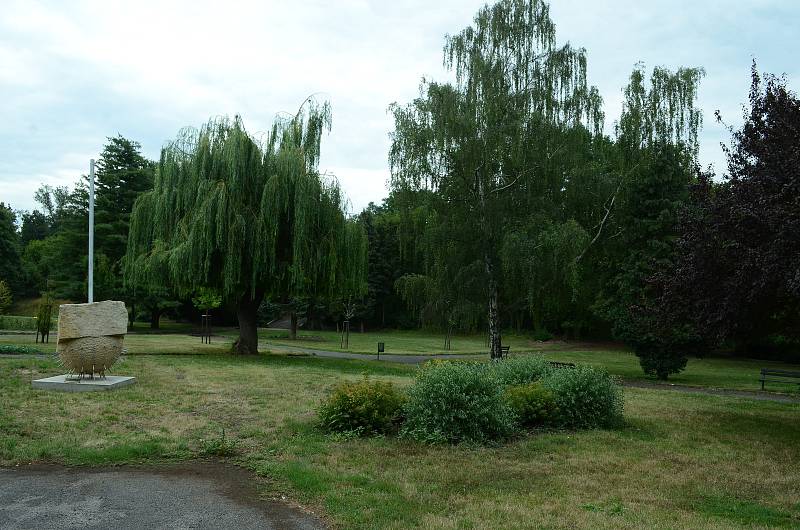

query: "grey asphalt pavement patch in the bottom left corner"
(0, 463), (324, 530)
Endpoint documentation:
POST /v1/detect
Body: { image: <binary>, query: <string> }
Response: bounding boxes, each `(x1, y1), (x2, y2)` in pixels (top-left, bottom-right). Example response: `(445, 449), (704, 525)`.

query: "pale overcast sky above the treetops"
(0, 0), (800, 211)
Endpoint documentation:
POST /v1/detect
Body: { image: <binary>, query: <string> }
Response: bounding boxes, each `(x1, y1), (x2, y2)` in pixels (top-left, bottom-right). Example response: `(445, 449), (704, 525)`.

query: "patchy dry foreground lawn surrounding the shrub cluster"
(0, 354), (800, 529)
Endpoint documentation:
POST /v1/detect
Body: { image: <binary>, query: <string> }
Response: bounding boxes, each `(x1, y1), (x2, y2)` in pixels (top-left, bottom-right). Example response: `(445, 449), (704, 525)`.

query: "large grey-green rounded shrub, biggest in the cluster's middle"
(402, 362), (515, 443)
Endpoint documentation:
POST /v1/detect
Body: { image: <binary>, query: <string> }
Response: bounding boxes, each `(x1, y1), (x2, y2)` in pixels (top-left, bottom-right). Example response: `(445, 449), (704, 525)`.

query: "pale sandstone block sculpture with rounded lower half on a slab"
(56, 300), (128, 377)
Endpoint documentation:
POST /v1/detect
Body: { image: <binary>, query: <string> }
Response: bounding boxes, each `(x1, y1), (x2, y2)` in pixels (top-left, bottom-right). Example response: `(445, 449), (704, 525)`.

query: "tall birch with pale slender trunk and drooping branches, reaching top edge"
(389, 0), (603, 358)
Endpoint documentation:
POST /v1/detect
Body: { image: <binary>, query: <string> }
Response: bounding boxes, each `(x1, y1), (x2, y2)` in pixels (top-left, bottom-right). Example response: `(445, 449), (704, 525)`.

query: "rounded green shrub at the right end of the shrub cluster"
(542, 366), (623, 429)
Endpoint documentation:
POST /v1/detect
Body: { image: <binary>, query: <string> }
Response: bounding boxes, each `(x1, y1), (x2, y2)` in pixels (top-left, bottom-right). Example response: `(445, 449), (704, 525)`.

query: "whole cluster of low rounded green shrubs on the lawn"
(319, 356), (623, 444)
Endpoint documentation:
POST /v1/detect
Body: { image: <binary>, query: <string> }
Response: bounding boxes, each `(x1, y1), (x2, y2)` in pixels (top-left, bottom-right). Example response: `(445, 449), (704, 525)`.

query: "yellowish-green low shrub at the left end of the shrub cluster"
(319, 377), (404, 436)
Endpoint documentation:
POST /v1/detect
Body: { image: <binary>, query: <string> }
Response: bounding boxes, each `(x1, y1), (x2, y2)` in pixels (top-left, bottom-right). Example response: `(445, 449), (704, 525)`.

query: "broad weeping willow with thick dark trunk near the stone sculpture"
(124, 99), (366, 354)
